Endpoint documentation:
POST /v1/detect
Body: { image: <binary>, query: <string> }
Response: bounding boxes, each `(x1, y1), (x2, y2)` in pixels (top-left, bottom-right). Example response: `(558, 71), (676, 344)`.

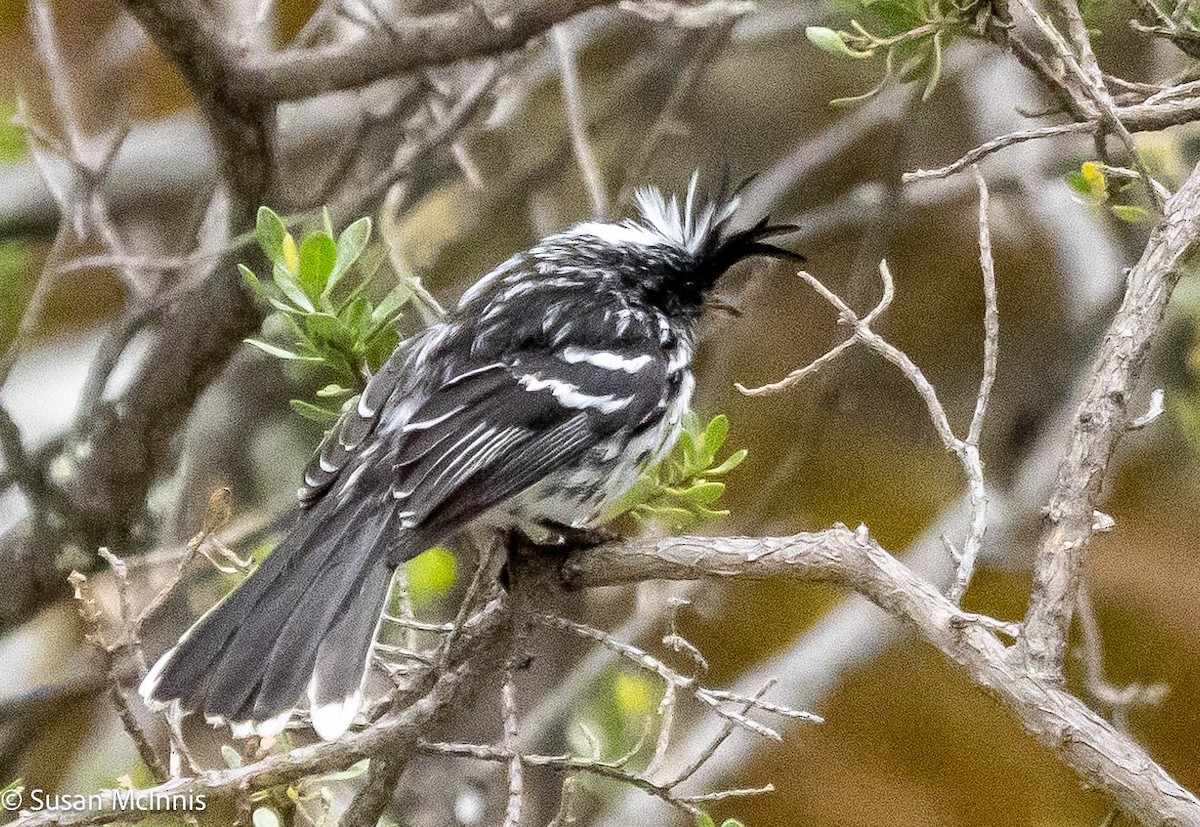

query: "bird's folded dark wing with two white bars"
(392, 331), (667, 532)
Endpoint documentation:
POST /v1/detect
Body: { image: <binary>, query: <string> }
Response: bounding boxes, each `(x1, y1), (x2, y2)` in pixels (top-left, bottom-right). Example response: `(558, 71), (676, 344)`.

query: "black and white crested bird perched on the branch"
(140, 176), (800, 739)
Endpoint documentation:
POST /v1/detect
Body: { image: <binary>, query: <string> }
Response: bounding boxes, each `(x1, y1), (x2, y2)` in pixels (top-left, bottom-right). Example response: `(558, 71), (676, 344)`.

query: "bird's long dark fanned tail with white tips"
(139, 497), (396, 741)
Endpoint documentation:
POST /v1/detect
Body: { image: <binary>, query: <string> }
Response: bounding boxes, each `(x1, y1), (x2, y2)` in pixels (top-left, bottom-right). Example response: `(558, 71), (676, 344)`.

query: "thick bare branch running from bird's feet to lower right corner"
(562, 527), (1200, 826)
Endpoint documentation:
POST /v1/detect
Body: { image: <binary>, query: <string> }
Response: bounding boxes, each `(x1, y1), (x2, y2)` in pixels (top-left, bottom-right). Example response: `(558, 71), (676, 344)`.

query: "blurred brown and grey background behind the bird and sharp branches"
(0, 0), (1200, 827)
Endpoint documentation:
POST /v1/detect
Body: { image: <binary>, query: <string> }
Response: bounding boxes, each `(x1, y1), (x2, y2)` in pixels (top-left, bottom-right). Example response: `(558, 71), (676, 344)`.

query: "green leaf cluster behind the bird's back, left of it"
(238, 206), (412, 425)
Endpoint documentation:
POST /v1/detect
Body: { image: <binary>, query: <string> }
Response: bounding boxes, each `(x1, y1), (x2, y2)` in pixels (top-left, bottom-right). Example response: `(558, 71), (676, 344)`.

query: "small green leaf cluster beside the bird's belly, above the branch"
(613, 410), (746, 532)
